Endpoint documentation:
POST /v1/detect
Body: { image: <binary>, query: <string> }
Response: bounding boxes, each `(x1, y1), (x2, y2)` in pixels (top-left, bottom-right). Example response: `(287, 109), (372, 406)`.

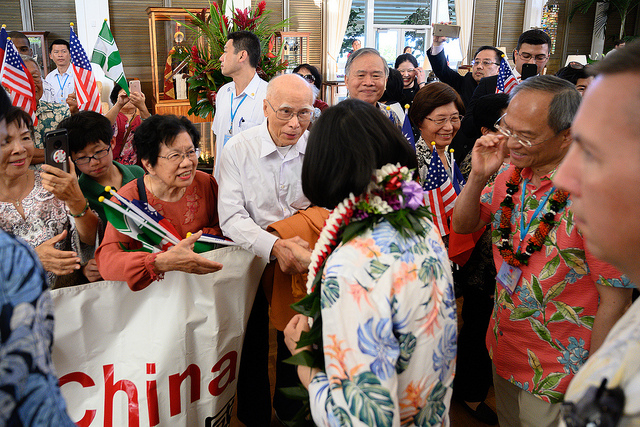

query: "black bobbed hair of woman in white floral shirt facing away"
(302, 99), (418, 208)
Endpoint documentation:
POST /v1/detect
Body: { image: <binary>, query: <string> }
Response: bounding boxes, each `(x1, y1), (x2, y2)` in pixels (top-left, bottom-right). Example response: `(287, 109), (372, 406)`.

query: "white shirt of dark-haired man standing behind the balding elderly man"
(212, 73), (268, 183)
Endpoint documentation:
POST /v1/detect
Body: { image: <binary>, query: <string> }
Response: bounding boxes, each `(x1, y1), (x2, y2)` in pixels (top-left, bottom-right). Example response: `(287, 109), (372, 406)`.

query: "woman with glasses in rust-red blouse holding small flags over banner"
(96, 115), (222, 291)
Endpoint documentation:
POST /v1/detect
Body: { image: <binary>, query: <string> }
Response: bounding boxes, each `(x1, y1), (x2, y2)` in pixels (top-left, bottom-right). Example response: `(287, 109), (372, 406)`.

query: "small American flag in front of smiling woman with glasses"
(423, 147), (457, 236)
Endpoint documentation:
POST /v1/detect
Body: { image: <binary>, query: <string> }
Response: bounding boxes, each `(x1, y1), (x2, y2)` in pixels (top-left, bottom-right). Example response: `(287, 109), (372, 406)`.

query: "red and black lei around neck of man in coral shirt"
(498, 168), (569, 267)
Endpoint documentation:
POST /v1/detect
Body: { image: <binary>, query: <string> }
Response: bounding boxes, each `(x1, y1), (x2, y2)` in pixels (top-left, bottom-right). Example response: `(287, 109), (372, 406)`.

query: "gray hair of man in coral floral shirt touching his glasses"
(511, 76), (582, 134)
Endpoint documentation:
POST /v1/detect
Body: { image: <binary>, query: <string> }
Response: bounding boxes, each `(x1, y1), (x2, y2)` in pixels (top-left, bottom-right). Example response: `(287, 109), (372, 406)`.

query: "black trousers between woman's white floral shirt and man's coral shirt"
(453, 287), (493, 402)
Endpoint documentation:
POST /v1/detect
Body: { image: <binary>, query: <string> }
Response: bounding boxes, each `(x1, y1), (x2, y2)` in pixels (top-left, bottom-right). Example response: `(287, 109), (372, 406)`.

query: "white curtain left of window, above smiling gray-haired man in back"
(322, 0), (351, 81)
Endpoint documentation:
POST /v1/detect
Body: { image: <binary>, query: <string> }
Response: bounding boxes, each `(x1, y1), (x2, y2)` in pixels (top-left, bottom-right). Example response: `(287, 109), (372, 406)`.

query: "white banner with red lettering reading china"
(51, 247), (266, 427)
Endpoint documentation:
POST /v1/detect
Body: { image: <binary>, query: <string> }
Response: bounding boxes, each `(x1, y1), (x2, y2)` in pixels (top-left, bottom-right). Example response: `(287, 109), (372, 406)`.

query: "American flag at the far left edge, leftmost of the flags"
(0, 37), (38, 126)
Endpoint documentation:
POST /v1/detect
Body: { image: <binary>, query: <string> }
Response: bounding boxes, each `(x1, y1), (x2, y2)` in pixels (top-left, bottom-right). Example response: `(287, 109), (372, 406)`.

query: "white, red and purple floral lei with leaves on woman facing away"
(281, 164), (431, 425)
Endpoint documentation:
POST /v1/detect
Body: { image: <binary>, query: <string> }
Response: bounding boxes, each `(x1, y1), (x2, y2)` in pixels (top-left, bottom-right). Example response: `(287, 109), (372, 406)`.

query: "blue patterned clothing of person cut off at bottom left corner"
(0, 231), (75, 426)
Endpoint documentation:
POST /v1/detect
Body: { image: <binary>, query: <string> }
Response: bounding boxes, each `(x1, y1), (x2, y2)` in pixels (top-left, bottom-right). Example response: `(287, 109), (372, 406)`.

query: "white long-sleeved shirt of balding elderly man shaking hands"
(218, 121), (311, 259)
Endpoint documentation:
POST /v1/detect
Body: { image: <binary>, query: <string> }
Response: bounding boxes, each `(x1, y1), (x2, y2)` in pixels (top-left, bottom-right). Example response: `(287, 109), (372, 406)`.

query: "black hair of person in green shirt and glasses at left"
(58, 111), (113, 153)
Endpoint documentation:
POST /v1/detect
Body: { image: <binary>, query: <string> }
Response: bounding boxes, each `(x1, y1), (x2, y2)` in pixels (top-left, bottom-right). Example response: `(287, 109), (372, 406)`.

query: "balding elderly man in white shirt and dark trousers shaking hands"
(218, 74), (314, 425)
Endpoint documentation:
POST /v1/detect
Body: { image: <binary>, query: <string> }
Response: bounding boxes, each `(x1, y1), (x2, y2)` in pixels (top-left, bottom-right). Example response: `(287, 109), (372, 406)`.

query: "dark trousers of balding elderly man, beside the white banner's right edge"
(237, 286), (271, 427)
